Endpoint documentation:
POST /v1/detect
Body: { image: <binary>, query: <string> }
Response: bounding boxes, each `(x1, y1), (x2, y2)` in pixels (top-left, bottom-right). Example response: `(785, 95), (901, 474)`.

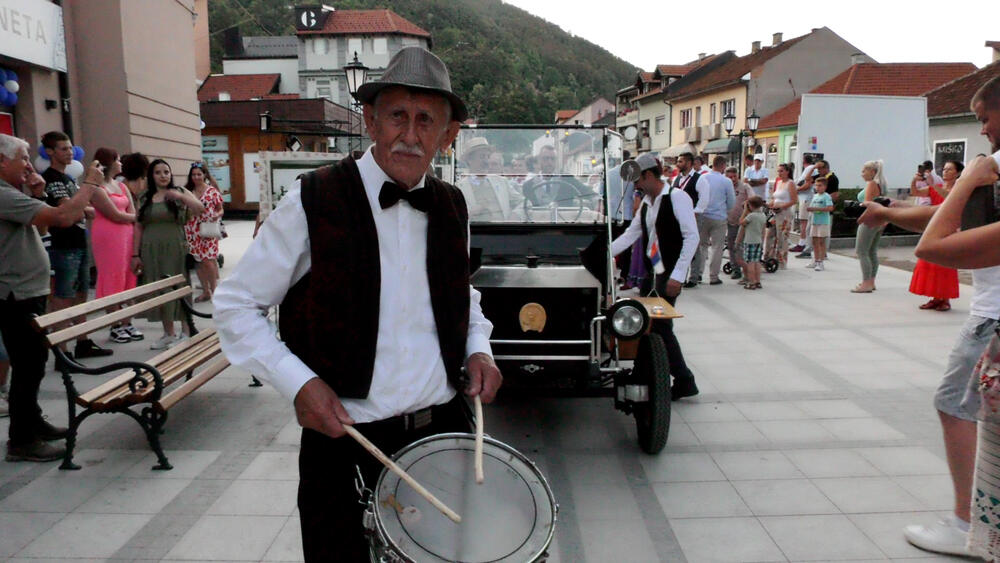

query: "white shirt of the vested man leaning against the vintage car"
(611, 186), (699, 283)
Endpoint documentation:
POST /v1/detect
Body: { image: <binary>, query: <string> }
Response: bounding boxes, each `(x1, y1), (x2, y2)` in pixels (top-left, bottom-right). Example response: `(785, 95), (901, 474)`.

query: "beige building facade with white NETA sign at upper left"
(0, 0), (208, 174)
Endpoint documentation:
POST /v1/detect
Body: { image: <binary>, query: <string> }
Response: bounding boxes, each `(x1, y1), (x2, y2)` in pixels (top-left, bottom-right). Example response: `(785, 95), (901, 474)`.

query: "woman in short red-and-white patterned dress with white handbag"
(184, 162), (222, 303)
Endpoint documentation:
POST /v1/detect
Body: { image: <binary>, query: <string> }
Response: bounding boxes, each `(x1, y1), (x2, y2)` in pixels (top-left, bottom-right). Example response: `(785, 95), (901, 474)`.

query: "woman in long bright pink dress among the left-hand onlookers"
(90, 147), (143, 343)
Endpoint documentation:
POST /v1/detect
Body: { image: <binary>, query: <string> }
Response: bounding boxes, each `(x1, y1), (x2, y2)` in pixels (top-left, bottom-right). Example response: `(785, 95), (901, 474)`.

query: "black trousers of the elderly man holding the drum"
(299, 395), (471, 562)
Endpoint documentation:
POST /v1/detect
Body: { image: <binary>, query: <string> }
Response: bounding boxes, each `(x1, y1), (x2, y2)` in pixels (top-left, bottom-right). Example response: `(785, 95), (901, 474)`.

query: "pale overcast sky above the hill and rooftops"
(504, 0), (1000, 71)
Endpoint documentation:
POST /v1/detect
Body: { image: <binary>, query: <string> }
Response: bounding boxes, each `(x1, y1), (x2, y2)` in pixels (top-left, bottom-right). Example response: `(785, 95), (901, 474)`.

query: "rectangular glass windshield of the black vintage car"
(452, 127), (621, 224)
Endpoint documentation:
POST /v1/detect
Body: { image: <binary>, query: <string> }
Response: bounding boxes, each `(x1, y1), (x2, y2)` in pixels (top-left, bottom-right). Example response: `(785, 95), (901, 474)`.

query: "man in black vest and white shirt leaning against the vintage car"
(611, 153), (698, 401)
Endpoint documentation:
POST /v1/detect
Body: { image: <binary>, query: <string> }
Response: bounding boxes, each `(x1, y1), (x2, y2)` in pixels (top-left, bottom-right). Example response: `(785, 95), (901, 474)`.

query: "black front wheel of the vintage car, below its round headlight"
(632, 334), (670, 454)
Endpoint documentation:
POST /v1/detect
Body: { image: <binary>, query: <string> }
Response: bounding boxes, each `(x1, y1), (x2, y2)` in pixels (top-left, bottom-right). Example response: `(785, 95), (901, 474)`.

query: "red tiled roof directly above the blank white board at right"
(758, 63), (976, 129)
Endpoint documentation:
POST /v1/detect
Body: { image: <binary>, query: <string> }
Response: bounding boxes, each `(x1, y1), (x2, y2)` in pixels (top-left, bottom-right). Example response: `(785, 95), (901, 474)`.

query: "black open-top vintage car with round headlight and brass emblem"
(448, 125), (678, 453)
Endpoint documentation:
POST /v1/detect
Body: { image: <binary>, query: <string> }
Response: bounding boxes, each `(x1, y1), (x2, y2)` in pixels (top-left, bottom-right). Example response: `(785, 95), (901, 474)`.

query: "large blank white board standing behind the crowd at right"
(798, 94), (929, 194)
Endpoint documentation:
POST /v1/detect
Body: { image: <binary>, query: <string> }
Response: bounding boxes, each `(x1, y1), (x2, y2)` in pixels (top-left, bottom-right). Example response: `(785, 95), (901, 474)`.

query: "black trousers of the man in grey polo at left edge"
(0, 294), (49, 445)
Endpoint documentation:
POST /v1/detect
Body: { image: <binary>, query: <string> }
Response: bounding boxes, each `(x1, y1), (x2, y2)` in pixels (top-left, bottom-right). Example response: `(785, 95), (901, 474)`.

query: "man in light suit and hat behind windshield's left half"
(457, 137), (522, 221)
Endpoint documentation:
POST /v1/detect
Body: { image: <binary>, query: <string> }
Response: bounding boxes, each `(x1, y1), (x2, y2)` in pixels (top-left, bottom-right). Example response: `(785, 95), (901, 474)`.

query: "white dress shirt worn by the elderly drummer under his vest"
(212, 149), (493, 422)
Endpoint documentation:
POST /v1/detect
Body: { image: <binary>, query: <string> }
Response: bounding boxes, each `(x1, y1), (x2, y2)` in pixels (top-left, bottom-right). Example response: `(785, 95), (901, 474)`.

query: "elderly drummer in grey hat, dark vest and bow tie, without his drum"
(213, 47), (502, 561)
